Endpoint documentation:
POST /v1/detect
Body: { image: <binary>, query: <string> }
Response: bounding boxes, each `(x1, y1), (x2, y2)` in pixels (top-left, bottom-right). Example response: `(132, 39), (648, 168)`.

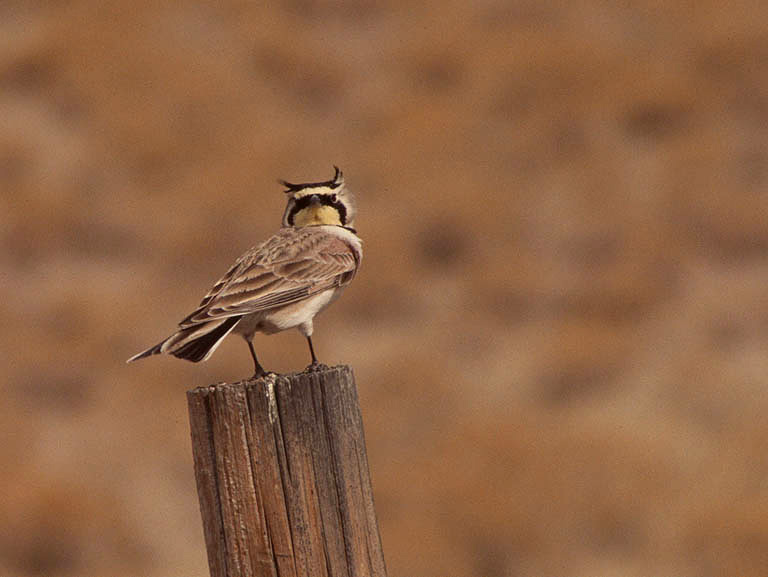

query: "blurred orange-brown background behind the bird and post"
(0, 0), (768, 577)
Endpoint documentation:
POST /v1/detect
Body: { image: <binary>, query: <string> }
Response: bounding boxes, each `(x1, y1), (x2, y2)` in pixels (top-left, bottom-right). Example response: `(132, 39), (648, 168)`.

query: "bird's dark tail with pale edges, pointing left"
(126, 317), (242, 363)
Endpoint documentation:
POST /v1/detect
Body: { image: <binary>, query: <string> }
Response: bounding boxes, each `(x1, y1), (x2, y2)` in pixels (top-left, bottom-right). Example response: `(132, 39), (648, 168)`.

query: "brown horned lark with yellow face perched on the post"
(127, 166), (363, 378)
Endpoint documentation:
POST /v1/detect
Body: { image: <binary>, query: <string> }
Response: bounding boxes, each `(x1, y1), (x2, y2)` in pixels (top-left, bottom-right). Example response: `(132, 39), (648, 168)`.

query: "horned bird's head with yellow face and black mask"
(280, 166), (355, 227)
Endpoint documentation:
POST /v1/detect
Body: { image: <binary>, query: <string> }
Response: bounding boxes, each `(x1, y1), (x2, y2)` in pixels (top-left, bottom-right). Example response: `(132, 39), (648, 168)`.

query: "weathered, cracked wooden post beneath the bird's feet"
(187, 365), (386, 577)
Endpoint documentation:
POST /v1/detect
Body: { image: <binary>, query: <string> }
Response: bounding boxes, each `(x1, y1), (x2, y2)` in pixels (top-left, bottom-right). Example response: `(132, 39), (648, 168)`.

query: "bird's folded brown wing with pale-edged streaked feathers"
(180, 228), (359, 327)
